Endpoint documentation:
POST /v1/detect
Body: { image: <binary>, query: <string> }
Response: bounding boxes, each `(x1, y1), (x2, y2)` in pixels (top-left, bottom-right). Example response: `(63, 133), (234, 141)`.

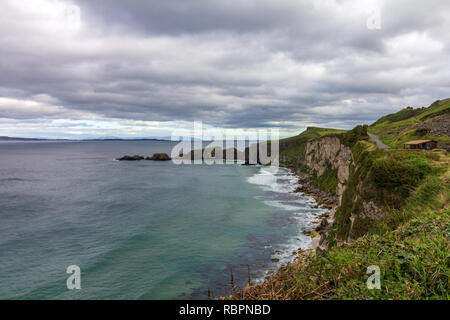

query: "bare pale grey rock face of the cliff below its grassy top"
(305, 137), (353, 203)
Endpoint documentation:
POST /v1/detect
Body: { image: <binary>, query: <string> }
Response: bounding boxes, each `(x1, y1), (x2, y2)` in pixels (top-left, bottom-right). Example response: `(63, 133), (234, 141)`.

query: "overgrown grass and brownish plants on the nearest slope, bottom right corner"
(234, 151), (450, 299)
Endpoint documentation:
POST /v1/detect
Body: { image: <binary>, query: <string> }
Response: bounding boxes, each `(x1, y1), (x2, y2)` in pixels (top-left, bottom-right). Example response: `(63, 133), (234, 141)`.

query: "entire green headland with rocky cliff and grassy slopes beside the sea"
(231, 99), (450, 299)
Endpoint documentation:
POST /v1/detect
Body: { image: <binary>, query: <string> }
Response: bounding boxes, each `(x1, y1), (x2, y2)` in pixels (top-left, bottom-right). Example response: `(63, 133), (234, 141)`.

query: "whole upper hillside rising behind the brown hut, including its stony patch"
(369, 99), (450, 151)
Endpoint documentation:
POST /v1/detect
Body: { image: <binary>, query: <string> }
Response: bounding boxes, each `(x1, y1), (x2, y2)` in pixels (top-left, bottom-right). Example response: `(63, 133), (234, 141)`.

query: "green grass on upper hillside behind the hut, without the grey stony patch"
(369, 99), (450, 148)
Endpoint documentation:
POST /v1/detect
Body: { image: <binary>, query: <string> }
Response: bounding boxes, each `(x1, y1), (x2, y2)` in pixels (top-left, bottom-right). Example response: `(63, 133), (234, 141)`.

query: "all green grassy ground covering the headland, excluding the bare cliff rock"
(233, 100), (450, 299)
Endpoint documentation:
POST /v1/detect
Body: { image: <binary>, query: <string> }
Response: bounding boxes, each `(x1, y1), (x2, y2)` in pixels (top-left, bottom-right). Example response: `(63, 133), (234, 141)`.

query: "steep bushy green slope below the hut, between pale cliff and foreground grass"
(334, 141), (449, 240)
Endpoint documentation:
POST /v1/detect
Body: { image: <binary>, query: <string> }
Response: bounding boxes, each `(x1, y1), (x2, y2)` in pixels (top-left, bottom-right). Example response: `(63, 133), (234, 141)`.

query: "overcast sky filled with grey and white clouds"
(0, 0), (450, 139)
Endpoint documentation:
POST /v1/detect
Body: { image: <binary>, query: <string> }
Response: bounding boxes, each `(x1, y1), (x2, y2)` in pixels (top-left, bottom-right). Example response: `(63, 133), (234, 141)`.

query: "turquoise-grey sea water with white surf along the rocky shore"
(0, 141), (321, 299)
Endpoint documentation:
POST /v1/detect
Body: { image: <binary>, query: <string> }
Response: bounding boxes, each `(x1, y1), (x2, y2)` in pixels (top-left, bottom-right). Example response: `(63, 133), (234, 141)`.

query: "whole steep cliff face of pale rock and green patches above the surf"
(281, 126), (386, 245)
